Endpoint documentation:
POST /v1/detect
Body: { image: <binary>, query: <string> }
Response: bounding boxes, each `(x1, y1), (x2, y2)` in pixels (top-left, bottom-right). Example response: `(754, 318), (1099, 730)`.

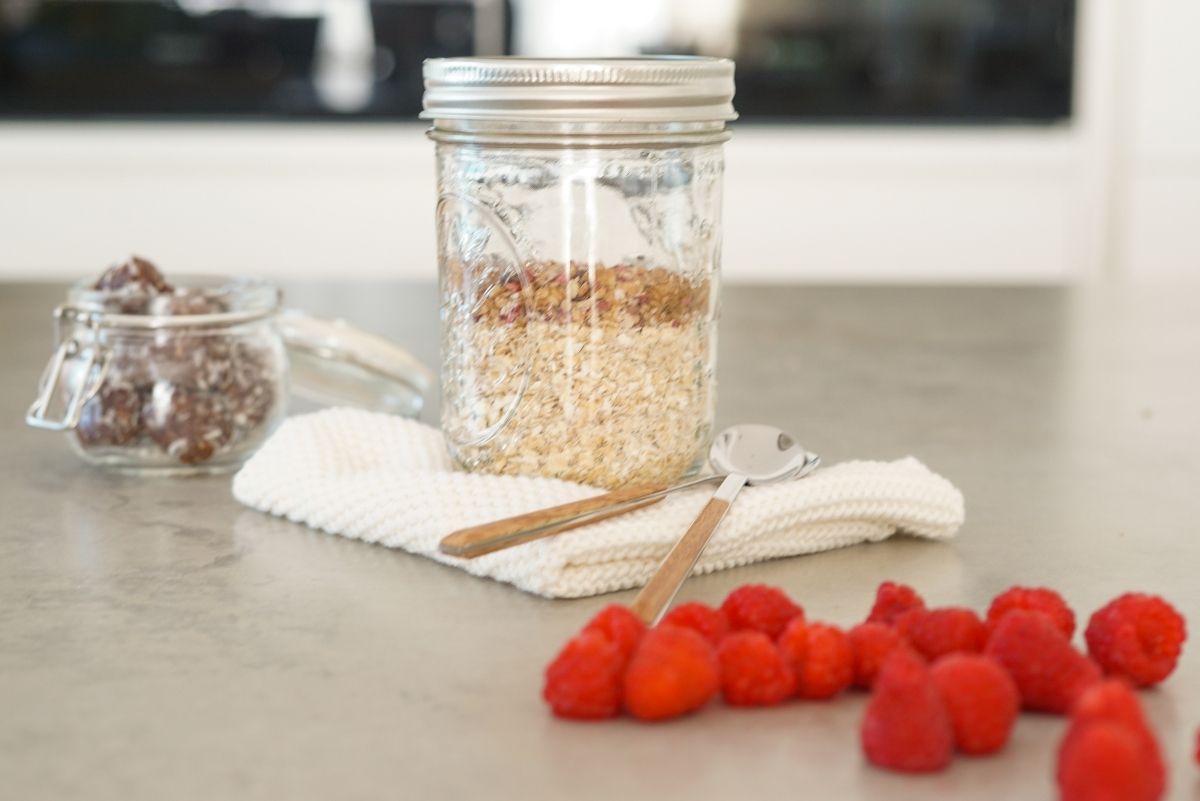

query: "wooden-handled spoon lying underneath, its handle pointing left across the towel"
(439, 423), (821, 559)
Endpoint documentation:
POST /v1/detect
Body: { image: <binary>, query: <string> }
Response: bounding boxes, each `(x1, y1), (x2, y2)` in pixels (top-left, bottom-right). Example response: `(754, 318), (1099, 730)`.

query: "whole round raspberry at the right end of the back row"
(1084, 592), (1187, 687)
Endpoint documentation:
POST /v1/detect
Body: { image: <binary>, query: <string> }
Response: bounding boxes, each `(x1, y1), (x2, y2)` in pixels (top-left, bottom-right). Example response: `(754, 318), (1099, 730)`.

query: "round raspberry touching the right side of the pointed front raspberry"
(930, 654), (1021, 754)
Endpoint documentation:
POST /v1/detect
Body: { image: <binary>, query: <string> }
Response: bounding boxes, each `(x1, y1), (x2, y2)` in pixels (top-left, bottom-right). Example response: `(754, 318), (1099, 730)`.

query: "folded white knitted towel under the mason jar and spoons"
(233, 409), (964, 598)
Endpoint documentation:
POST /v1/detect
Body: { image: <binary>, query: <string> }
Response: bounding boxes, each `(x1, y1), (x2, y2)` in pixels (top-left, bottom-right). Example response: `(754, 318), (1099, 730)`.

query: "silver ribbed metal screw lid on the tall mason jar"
(421, 56), (737, 122)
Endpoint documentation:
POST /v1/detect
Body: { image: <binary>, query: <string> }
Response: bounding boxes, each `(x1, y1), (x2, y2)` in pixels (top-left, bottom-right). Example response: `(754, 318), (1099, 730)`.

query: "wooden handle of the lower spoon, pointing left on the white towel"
(439, 483), (668, 559)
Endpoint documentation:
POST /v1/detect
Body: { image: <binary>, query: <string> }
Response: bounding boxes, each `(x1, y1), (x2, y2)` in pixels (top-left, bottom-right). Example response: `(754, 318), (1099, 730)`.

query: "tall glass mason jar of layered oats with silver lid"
(422, 58), (736, 488)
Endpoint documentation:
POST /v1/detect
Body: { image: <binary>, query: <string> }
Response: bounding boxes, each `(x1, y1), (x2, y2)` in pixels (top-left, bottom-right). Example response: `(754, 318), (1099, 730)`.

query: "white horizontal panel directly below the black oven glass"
(0, 125), (1082, 281)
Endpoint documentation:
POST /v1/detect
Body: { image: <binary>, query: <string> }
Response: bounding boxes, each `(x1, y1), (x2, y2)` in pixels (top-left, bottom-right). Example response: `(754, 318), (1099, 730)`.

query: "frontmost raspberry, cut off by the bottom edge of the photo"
(1058, 721), (1162, 801)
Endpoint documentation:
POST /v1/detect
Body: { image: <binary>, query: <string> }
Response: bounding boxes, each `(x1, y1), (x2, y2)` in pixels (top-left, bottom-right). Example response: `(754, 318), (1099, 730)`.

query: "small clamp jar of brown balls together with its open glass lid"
(25, 258), (433, 474)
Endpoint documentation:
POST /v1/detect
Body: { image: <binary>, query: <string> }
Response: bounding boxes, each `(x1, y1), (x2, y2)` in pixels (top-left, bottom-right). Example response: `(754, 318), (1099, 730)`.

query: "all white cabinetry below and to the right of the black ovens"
(0, 0), (1200, 282)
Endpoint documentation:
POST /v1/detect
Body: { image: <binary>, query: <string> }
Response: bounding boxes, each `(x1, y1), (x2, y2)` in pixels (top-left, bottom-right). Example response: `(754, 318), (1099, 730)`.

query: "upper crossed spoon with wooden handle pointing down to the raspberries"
(630, 424), (820, 626)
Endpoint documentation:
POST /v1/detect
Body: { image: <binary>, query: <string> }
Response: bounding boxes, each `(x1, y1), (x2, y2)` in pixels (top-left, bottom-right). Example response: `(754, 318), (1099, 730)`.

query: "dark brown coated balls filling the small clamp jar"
(66, 257), (284, 465)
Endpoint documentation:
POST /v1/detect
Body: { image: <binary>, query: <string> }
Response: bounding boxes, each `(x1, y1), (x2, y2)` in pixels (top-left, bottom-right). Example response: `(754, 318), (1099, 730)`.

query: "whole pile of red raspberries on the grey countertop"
(542, 582), (1200, 801)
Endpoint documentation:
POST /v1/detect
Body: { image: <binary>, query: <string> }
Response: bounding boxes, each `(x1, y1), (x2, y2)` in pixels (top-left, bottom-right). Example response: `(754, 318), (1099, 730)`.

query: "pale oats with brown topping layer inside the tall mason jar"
(443, 261), (713, 488)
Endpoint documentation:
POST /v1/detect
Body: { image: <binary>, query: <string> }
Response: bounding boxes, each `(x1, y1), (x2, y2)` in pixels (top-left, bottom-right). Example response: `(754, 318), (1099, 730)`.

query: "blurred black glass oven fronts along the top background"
(0, 0), (1075, 124)
